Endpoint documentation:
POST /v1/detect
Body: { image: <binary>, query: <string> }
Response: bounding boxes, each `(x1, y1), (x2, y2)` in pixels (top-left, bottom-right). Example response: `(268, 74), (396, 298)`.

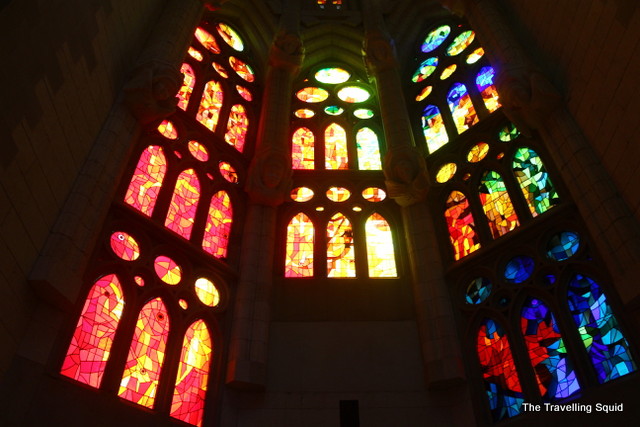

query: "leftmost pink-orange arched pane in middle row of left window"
(124, 145), (167, 216)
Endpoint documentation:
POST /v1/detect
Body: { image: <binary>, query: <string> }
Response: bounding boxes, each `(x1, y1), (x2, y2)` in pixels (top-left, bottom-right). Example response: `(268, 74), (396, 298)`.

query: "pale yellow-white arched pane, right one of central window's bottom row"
(364, 213), (398, 277)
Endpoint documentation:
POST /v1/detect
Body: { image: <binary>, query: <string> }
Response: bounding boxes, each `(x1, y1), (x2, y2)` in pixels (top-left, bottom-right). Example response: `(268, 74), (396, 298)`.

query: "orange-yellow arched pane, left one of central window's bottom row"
(284, 212), (315, 277)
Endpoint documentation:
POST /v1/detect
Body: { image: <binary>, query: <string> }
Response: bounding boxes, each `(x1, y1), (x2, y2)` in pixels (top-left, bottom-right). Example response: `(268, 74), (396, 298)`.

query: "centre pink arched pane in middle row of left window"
(164, 169), (200, 239)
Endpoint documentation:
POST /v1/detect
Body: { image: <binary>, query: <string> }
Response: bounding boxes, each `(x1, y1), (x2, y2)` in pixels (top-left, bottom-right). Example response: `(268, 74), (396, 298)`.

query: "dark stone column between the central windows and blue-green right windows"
(364, 22), (464, 388)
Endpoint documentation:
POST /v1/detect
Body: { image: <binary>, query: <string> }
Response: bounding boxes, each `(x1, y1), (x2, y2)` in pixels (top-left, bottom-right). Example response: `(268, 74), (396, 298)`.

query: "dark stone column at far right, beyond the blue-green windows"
(452, 0), (640, 315)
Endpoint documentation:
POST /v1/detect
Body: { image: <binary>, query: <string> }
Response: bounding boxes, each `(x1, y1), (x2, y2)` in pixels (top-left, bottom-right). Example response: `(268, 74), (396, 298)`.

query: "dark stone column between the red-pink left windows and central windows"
(227, 10), (304, 389)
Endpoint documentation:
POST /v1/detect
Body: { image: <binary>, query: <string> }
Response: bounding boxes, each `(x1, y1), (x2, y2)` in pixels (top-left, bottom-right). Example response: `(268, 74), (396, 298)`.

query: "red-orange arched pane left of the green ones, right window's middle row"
(444, 191), (480, 260)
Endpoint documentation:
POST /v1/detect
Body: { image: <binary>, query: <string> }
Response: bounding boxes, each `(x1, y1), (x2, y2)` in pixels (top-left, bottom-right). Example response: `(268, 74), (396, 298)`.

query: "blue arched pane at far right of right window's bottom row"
(567, 274), (637, 383)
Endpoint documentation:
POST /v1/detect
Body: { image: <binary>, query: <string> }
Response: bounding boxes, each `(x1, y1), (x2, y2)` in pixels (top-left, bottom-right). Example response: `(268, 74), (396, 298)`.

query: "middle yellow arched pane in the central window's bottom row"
(327, 212), (356, 277)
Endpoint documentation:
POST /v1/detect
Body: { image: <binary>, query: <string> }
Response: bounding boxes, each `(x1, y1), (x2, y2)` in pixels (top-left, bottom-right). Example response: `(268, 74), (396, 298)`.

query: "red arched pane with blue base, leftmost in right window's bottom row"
(477, 319), (524, 421)
